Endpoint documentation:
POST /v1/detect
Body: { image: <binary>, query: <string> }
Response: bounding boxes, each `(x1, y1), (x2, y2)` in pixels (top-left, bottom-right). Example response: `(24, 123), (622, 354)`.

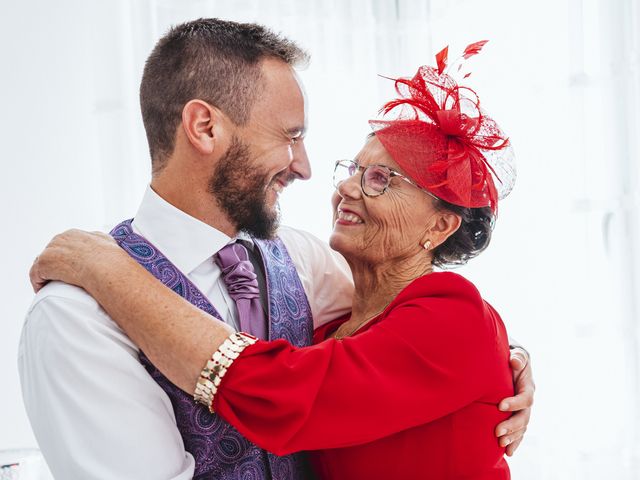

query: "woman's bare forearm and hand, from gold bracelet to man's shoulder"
(30, 230), (233, 394)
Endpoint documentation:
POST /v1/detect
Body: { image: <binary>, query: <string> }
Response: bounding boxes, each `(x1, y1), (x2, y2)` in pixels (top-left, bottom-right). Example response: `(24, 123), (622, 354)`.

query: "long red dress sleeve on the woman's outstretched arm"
(213, 274), (506, 455)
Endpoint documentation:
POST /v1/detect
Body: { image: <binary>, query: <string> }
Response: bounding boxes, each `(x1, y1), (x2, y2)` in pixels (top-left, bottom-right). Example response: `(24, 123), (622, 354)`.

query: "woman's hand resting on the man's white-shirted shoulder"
(29, 230), (129, 292)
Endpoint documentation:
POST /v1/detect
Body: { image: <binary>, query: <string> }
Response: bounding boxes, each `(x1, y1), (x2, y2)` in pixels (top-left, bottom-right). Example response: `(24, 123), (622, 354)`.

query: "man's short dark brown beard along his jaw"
(209, 135), (280, 239)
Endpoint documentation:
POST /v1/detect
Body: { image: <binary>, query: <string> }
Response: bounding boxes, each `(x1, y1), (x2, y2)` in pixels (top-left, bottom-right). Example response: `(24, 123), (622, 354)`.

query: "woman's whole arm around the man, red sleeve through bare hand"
(33, 232), (504, 455)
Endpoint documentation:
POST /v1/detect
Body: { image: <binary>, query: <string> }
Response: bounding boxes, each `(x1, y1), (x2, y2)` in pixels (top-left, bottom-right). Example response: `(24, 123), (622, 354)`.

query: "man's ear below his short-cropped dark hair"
(182, 99), (225, 155)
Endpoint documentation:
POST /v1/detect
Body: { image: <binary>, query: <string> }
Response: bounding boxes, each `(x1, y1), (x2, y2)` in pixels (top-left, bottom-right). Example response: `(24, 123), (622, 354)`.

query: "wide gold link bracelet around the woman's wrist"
(193, 332), (258, 413)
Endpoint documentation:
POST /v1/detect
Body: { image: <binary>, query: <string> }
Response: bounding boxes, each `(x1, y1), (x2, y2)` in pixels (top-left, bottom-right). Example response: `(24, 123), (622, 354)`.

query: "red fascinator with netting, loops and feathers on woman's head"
(369, 41), (516, 213)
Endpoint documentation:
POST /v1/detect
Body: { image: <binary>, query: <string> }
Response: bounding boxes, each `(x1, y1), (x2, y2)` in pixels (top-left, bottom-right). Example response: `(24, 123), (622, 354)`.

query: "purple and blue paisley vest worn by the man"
(111, 220), (313, 480)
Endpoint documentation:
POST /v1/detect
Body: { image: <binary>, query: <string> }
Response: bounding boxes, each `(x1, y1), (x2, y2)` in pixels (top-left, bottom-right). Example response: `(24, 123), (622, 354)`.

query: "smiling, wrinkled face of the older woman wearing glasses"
(329, 137), (438, 263)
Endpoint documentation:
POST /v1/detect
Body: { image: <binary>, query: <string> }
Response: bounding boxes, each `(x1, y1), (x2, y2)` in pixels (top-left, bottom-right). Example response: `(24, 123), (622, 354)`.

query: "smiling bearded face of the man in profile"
(209, 59), (311, 238)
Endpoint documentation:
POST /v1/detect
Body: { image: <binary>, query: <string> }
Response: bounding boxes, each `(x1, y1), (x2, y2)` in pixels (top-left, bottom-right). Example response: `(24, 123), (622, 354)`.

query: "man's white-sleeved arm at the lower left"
(18, 283), (194, 480)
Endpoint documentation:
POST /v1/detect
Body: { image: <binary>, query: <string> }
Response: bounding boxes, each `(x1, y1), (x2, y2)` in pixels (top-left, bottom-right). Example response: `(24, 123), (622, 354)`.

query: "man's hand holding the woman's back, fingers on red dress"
(496, 347), (536, 456)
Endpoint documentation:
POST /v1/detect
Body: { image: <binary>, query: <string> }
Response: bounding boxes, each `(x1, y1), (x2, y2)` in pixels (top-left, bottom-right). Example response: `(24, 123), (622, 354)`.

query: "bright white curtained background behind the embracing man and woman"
(0, 0), (640, 480)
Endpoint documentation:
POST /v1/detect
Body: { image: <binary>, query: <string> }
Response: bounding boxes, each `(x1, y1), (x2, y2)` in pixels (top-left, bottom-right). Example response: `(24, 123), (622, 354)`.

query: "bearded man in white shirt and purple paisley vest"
(20, 19), (533, 479)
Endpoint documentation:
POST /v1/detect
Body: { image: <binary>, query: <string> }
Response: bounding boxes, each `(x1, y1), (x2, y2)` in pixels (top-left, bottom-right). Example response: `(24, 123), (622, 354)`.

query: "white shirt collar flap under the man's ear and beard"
(133, 186), (235, 274)
